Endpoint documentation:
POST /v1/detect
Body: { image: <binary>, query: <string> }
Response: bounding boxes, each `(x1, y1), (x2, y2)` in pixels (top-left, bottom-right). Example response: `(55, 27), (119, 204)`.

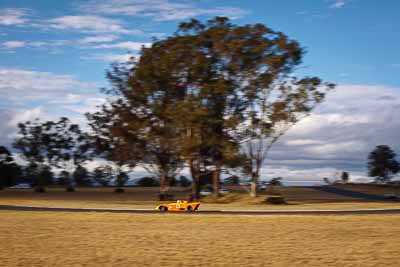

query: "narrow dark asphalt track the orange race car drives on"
(0, 205), (400, 215)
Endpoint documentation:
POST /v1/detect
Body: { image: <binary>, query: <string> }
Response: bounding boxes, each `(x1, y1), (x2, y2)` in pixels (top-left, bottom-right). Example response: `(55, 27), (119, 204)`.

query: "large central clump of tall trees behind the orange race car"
(88, 17), (333, 197)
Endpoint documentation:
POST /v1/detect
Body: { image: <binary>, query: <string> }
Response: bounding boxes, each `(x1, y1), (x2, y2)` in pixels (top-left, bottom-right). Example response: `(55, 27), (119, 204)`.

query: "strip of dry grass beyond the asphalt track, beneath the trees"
(0, 187), (400, 210)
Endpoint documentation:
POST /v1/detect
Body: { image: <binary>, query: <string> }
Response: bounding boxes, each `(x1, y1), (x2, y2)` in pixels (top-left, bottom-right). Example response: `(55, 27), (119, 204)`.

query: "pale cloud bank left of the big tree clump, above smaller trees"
(0, 68), (105, 149)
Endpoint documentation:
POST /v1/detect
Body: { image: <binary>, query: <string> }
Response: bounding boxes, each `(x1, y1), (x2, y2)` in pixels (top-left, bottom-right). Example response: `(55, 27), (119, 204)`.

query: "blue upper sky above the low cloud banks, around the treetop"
(0, 0), (400, 86)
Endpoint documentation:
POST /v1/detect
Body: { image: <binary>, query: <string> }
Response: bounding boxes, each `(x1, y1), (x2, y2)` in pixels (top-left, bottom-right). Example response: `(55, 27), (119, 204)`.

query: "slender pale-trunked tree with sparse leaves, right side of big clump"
(242, 78), (334, 197)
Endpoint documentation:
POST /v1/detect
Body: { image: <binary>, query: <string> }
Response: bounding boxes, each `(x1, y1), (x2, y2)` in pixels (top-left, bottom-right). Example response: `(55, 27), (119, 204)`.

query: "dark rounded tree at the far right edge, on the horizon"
(368, 145), (400, 182)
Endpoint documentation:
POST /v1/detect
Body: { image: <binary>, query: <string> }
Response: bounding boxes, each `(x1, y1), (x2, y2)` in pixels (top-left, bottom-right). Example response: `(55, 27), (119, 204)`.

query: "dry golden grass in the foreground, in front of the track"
(0, 211), (400, 267)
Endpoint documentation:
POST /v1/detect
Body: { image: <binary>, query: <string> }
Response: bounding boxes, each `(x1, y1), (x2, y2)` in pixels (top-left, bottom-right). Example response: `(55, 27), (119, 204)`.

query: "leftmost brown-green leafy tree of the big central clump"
(87, 65), (183, 199)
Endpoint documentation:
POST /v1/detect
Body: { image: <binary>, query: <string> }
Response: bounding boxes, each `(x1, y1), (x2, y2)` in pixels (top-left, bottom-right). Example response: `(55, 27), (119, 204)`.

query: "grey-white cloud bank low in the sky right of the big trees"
(266, 85), (400, 175)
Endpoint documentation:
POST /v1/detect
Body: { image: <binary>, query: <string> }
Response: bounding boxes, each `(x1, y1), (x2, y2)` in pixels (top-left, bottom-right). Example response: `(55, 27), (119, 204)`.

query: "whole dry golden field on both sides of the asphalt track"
(0, 187), (400, 267)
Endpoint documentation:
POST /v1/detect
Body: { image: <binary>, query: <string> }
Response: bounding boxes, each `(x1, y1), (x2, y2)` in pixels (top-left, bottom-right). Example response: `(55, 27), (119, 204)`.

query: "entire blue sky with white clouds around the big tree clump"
(0, 0), (400, 183)
